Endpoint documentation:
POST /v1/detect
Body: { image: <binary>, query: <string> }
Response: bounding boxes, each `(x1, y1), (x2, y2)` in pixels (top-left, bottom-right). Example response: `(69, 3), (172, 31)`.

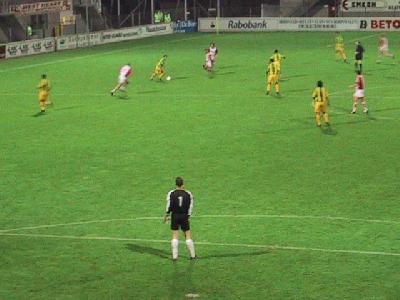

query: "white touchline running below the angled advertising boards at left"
(0, 35), (201, 73)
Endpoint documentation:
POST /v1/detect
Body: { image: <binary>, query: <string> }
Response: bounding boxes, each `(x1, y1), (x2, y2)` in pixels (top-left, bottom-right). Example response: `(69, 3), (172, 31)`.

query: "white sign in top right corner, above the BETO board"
(340, 0), (400, 13)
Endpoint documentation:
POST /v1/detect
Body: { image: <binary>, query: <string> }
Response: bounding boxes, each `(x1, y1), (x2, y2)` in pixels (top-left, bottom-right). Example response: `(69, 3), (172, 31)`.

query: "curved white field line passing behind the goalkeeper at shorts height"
(0, 215), (400, 233)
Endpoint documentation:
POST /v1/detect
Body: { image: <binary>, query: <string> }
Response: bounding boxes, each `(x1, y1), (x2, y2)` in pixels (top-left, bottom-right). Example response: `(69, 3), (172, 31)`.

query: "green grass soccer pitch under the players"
(0, 33), (400, 300)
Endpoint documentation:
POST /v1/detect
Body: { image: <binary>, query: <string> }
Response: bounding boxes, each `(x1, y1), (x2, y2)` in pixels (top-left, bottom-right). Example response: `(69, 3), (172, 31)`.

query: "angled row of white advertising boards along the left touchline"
(0, 24), (173, 59)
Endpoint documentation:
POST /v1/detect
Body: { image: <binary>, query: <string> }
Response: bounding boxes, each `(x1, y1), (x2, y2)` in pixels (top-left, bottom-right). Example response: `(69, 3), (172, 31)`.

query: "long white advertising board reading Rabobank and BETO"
(199, 17), (400, 32)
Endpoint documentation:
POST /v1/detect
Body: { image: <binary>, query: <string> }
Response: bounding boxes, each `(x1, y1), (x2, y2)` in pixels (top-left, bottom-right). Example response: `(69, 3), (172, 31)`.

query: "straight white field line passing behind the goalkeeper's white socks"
(0, 233), (400, 257)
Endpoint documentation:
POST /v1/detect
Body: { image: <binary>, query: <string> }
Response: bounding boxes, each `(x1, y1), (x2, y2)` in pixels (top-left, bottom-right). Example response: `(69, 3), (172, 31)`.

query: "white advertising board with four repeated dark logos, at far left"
(6, 38), (56, 58)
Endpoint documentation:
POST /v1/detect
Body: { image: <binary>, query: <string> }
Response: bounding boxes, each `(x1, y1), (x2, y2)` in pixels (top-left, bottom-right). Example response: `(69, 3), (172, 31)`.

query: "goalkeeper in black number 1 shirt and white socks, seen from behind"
(164, 177), (196, 261)
